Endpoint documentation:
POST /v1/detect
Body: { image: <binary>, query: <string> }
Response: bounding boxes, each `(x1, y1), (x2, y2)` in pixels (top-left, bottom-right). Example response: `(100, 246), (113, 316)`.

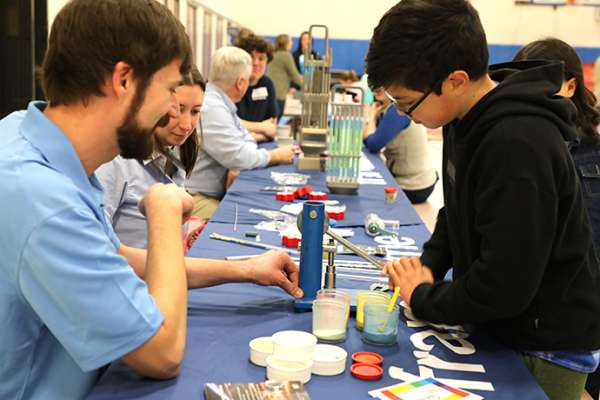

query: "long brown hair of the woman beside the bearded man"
(161, 65), (206, 177)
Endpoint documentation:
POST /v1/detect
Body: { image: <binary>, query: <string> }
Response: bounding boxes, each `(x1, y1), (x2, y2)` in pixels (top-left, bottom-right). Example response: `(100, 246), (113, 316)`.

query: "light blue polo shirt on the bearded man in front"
(0, 102), (163, 399)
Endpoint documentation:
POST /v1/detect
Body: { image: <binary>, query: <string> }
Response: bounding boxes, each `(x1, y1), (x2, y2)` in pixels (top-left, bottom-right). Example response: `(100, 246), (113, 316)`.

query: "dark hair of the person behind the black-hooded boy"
(513, 38), (600, 141)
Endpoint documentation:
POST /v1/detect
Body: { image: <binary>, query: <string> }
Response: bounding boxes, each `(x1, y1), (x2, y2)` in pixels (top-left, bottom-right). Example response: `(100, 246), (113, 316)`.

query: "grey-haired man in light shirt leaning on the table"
(185, 46), (294, 219)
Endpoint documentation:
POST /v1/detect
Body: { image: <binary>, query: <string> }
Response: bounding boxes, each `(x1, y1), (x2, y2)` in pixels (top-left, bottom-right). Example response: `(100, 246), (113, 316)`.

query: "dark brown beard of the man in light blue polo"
(117, 77), (169, 161)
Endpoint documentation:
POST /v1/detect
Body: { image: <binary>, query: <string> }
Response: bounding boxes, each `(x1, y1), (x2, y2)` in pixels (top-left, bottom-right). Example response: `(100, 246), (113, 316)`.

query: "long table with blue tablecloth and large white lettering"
(89, 147), (547, 400)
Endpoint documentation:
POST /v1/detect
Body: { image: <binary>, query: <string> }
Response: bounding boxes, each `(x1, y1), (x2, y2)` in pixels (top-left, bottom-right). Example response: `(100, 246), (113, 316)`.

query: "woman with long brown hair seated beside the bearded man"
(96, 67), (206, 248)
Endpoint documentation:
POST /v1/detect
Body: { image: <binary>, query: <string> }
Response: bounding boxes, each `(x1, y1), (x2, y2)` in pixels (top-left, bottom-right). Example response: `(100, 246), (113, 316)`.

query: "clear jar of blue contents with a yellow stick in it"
(361, 303), (400, 346)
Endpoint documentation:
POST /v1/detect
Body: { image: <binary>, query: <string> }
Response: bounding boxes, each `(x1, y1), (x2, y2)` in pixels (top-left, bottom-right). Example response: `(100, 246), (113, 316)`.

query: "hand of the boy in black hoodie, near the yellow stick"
(381, 257), (433, 305)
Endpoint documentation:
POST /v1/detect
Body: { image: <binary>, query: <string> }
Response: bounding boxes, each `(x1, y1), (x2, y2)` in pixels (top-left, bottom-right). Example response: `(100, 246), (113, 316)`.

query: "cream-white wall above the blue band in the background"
(48, 0), (600, 47)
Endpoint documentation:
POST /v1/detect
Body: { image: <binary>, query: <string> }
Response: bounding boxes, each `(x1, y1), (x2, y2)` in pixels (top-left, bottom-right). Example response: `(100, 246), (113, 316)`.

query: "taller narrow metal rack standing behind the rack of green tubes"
(298, 25), (331, 170)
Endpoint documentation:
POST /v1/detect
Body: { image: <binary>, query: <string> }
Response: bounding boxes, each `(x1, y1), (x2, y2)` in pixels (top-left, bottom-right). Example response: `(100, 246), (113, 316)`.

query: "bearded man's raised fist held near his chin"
(138, 183), (194, 218)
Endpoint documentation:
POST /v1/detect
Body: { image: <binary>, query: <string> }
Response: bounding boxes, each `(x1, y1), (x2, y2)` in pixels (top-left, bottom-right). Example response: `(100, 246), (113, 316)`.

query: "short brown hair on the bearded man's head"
(42, 0), (192, 106)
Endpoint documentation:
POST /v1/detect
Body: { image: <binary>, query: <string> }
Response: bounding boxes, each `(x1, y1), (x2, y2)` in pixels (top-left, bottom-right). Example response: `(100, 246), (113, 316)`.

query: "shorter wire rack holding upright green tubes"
(326, 85), (365, 194)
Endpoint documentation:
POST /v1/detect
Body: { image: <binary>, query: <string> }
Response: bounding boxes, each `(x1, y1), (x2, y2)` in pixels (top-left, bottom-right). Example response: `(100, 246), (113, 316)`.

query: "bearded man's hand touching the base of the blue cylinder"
(248, 250), (304, 298)
